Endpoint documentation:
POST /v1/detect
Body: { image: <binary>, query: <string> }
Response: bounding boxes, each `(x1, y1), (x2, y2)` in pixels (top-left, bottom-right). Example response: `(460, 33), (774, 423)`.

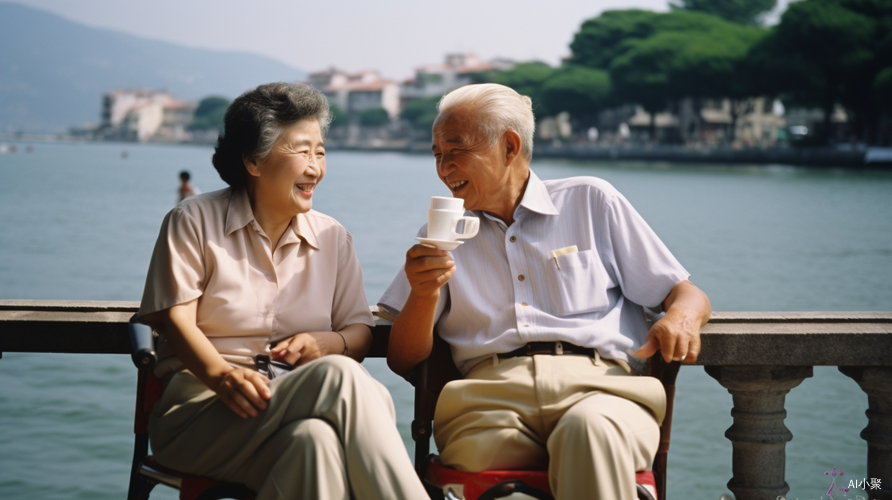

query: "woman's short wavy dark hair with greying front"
(212, 82), (331, 188)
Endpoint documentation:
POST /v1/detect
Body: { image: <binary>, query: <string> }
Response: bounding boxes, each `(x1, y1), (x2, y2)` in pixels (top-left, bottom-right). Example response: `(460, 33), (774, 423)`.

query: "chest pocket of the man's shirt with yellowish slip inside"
(546, 250), (613, 316)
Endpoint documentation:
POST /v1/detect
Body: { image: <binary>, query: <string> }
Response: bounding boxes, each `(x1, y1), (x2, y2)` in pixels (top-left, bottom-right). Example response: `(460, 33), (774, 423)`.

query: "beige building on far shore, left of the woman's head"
(97, 89), (197, 142)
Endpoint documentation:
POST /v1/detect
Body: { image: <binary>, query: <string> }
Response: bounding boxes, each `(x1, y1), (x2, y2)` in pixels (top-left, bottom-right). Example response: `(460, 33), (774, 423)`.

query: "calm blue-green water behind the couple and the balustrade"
(0, 144), (892, 500)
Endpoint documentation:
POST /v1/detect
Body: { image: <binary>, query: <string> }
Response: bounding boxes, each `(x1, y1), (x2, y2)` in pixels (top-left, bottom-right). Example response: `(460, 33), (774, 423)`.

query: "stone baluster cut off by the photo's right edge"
(839, 366), (892, 500)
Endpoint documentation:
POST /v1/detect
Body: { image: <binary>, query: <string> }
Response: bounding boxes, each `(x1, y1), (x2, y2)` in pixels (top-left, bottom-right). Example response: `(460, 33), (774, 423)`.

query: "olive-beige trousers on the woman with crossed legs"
(149, 356), (426, 500)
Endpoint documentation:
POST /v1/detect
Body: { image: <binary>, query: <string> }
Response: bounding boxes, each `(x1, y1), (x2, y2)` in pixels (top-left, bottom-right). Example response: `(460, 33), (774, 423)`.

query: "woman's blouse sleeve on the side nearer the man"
(331, 231), (375, 330)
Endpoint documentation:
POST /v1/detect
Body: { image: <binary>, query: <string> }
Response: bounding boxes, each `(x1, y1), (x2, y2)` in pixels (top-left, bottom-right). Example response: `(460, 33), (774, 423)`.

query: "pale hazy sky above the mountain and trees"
(15, 0), (786, 79)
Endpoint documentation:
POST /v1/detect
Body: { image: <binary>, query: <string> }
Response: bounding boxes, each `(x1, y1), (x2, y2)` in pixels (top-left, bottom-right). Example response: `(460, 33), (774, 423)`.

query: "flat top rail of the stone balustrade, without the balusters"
(0, 300), (892, 366)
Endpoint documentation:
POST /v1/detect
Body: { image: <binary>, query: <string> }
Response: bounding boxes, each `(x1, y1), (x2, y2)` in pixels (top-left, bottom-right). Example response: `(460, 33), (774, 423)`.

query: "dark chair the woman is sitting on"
(127, 316), (255, 500)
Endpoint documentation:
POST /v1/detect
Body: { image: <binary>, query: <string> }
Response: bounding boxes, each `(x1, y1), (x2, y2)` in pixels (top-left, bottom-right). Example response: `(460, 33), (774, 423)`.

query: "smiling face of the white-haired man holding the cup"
(431, 107), (513, 212)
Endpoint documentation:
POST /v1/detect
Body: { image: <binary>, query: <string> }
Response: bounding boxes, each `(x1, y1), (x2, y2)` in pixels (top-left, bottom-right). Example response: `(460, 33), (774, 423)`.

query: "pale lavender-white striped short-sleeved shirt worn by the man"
(379, 172), (689, 374)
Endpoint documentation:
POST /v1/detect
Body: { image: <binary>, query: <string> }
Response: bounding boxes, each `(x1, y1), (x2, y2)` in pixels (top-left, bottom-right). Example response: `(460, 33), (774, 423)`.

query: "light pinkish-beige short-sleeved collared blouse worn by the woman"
(139, 189), (374, 375)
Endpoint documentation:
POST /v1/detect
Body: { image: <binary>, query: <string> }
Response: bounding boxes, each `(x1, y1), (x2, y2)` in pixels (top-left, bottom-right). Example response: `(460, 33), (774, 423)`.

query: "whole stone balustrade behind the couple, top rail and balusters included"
(0, 300), (892, 500)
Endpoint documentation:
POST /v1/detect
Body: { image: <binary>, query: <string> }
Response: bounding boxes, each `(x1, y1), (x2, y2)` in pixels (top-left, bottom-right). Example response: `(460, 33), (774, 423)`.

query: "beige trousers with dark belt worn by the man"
(434, 355), (666, 500)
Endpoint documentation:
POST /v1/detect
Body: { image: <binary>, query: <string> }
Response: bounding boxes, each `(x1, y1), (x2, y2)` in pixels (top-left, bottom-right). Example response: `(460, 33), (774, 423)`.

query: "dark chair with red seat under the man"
(412, 335), (681, 500)
